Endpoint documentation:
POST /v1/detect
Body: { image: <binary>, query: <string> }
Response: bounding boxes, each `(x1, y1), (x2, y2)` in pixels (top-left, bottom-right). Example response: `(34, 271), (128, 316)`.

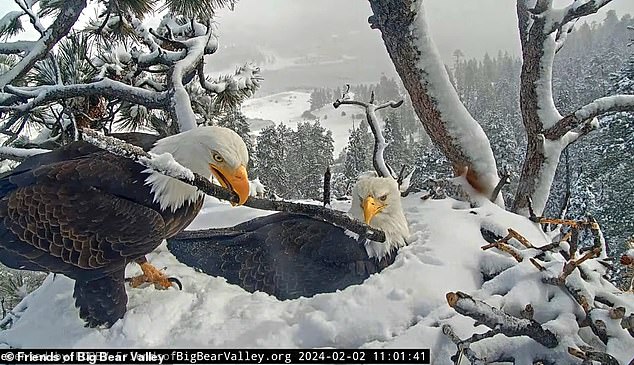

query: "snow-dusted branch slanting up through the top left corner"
(0, 0), (86, 90)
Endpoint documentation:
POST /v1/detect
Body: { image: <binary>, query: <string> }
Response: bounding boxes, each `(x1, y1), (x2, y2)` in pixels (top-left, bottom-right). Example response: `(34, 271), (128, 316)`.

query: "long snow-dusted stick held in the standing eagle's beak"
(82, 129), (385, 242)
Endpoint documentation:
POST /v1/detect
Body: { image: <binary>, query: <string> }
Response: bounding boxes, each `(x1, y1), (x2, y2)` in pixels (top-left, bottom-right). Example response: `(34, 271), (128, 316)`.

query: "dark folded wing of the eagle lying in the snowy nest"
(168, 213), (380, 299)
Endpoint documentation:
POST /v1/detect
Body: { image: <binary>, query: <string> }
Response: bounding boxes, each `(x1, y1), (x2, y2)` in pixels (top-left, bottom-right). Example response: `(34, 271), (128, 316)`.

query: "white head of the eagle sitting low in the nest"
(348, 176), (409, 259)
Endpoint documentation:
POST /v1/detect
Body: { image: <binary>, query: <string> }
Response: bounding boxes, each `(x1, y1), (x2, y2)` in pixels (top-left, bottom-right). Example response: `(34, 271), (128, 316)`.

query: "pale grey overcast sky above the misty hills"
(0, 0), (634, 62)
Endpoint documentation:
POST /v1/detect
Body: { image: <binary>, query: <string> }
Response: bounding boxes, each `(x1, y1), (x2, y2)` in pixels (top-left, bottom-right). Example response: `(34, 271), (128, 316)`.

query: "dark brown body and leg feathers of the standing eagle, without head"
(0, 133), (203, 326)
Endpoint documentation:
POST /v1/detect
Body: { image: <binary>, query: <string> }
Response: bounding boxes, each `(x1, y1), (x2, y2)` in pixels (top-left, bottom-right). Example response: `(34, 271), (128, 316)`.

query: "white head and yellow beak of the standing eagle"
(145, 126), (249, 211)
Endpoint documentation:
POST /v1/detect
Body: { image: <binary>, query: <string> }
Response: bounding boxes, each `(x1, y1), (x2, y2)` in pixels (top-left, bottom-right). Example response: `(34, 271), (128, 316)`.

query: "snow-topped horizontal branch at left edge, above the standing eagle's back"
(0, 78), (168, 112)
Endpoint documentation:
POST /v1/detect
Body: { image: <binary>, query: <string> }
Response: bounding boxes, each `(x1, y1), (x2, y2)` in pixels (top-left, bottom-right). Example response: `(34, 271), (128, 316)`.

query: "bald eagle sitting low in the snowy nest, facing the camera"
(168, 177), (409, 300)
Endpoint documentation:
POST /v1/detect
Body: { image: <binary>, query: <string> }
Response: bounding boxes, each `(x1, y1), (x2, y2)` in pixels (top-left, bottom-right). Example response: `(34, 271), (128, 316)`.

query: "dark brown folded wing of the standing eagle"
(0, 151), (165, 279)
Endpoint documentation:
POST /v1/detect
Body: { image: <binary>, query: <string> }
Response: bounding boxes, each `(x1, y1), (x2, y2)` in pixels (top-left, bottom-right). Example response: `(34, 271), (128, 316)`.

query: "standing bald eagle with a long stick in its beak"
(0, 127), (249, 327)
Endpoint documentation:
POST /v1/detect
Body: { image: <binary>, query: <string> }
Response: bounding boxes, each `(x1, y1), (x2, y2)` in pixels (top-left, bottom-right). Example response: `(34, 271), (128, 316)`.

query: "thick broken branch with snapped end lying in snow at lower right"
(446, 292), (559, 348)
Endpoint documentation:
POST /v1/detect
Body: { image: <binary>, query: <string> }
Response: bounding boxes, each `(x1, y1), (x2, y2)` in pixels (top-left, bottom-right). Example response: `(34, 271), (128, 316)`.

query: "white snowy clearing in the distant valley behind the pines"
(242, 91), (382, 158)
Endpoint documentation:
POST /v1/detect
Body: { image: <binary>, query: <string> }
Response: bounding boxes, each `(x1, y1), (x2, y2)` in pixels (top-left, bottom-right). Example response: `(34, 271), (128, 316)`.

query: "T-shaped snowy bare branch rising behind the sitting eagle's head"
(332, 92), (403, 178)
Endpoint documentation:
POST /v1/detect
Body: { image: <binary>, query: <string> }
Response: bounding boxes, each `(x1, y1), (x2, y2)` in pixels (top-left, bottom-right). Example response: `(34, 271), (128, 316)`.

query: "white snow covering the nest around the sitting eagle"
(0, 195), (634, 364)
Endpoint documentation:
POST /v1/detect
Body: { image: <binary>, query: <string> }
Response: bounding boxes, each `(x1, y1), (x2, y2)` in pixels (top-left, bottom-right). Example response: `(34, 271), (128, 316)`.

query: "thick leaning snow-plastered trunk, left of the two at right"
(369, 0), (503, 204)
